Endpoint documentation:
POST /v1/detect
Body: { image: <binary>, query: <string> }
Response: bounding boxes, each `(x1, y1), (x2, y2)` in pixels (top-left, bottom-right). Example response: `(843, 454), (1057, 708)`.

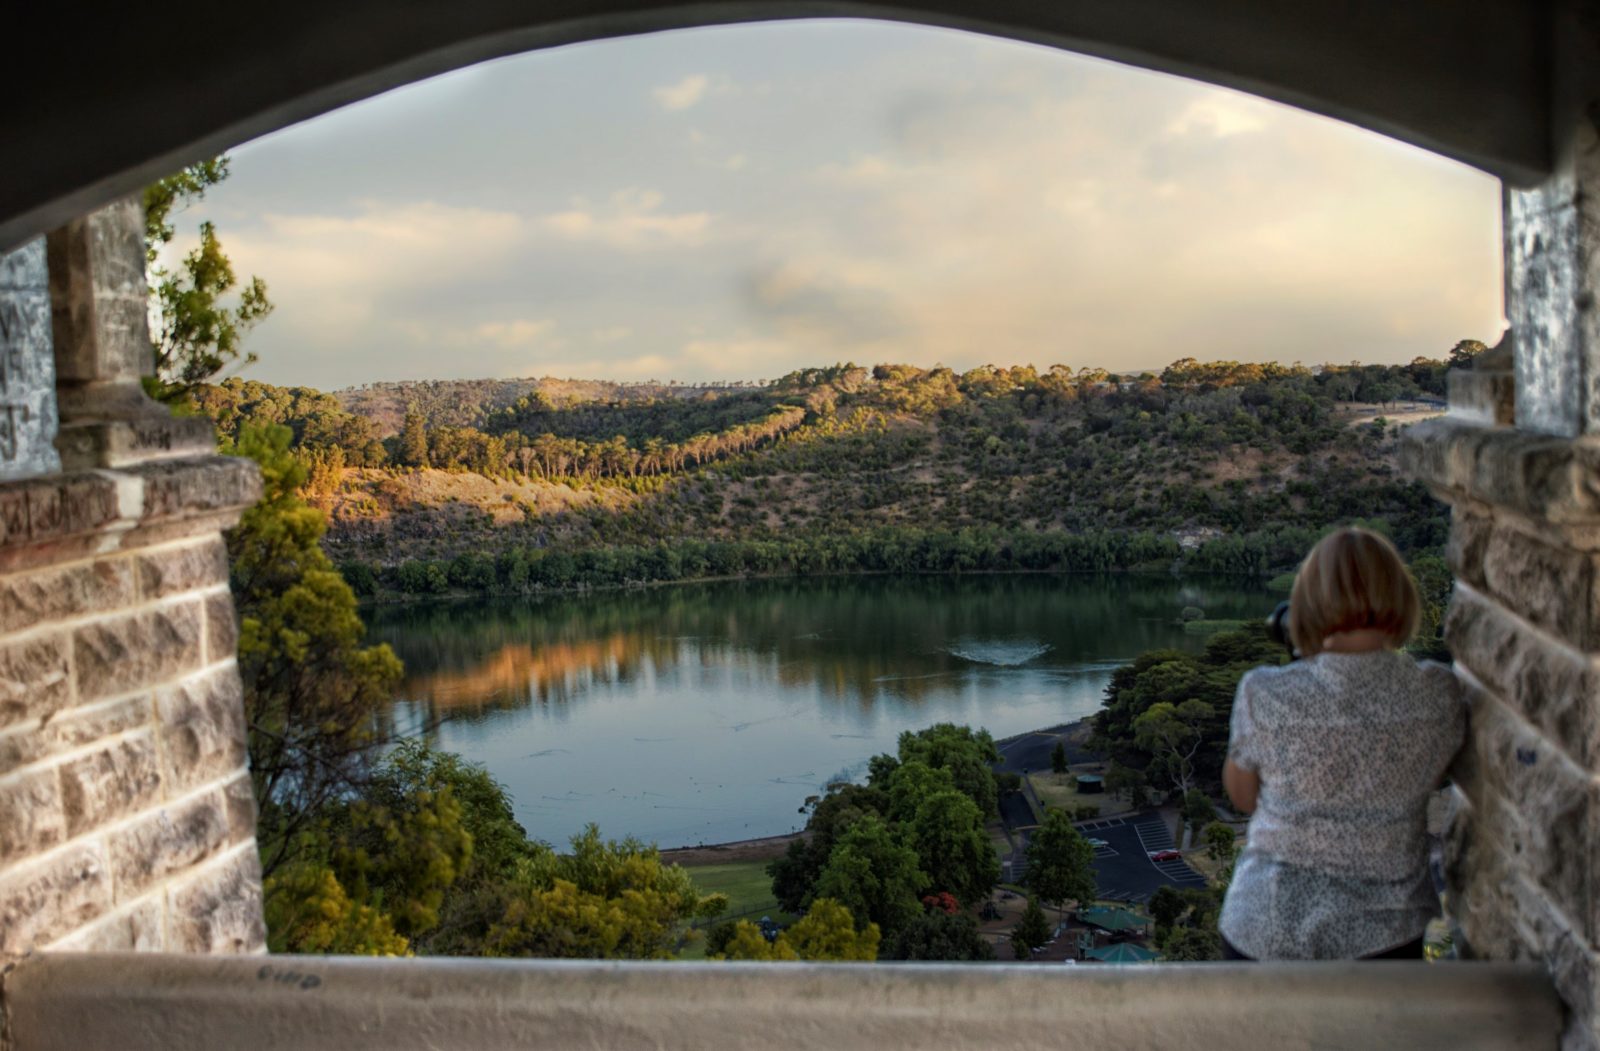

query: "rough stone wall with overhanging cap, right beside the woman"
(1405, 418), (1600, 1048)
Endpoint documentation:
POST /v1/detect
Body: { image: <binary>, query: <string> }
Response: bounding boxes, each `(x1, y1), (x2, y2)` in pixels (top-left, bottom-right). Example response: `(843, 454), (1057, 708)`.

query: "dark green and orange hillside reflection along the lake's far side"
(373, 576), (1270, 721)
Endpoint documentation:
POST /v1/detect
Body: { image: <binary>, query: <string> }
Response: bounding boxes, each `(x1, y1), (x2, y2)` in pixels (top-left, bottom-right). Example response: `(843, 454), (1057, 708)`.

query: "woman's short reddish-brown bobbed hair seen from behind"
(1290, 528), (1421, 657)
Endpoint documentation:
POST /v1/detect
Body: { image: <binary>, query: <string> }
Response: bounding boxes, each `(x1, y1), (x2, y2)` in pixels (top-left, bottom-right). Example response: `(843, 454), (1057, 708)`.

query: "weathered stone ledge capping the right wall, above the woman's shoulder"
(1400, 416), (1600, 527)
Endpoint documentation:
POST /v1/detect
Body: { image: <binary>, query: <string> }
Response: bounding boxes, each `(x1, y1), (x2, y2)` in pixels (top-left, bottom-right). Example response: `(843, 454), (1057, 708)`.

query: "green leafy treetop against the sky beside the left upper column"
(144, 154), (272, 402)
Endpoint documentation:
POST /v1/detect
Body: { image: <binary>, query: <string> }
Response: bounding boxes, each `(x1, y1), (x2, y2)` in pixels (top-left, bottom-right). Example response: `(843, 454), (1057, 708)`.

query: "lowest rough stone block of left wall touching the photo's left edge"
(0, 843), (110, 953)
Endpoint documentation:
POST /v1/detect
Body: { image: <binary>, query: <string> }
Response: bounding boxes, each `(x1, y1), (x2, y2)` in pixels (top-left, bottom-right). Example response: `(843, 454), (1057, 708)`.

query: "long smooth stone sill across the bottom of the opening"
(5, 939), (1563, 1051)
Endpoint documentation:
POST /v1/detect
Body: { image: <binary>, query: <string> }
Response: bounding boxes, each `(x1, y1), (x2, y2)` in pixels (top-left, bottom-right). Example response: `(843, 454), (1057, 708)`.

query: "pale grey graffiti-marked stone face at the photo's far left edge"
(0, 240), (61, 482)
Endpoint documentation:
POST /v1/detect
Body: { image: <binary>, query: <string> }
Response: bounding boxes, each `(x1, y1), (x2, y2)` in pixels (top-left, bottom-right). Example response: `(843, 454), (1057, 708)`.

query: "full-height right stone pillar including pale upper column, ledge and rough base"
(1402, 10), (1600, 1051)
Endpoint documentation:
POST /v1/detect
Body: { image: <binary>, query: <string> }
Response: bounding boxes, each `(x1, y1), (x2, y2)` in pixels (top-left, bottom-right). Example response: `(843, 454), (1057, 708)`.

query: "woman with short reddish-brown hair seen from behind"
(1219, 529), (1466, 960)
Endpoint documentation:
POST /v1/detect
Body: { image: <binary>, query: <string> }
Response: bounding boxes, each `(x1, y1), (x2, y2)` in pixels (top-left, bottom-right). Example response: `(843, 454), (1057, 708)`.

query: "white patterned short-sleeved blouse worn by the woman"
(1219, 649), (1466, 960)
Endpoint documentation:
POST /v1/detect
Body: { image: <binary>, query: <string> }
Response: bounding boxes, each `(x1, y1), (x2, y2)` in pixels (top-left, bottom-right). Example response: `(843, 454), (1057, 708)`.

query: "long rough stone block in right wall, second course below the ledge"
(1445, 582), (1600, 769)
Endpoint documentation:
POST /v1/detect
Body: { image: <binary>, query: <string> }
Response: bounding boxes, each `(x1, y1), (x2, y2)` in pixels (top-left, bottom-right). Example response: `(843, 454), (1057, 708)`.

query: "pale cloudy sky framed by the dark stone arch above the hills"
(179, 21), (1504, 389)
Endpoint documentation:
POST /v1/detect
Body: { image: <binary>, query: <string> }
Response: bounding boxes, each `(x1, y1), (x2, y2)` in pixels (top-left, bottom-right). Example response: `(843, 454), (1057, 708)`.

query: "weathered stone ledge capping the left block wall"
(0, 456), (261, 573)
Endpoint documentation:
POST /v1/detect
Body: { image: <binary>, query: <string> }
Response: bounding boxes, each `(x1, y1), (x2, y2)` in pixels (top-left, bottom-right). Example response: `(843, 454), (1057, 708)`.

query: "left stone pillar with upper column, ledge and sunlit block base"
(0, 202), (264, 963)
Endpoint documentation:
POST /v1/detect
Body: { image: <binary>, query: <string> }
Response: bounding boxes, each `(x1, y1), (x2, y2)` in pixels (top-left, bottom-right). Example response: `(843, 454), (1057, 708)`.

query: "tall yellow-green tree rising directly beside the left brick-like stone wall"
(224, 427), (400, 875)
